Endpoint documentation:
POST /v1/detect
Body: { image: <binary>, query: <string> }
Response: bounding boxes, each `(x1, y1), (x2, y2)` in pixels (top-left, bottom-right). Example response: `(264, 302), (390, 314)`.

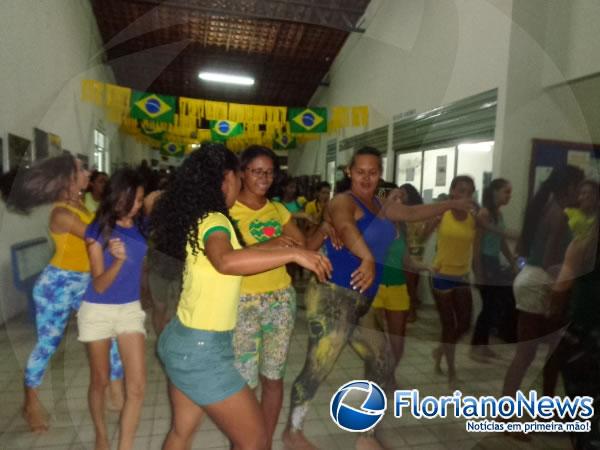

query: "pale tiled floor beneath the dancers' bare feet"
(0, 294), (570, 450)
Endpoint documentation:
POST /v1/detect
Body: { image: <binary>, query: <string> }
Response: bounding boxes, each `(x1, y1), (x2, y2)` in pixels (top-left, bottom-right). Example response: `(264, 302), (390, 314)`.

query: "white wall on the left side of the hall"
(0, 0), (120, 323)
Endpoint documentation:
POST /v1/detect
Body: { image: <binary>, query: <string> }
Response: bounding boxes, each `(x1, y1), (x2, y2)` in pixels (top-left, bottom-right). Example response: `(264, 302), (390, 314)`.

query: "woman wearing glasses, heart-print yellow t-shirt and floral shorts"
(229, 146), (338, 448)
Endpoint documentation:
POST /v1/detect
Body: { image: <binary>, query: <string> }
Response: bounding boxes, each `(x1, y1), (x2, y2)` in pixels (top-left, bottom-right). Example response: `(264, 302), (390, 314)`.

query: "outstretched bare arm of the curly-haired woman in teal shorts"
(204, 231), (332, 281)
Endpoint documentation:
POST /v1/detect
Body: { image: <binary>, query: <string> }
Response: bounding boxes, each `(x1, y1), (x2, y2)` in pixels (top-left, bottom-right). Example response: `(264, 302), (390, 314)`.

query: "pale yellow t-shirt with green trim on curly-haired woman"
(177, 213), (242, 331)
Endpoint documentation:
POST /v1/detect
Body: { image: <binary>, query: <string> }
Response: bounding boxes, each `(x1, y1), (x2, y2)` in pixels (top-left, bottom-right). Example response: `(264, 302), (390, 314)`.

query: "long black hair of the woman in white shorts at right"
(517, 165), (583, 258)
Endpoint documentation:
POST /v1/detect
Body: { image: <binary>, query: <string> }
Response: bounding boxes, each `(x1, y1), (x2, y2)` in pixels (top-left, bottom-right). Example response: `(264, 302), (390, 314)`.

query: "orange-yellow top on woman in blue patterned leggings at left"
(50, 202), (94, 272)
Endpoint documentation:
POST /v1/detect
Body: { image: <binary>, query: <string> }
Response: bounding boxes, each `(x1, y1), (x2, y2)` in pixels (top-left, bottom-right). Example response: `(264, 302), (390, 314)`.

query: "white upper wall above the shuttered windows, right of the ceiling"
(290, 0), (512, 175)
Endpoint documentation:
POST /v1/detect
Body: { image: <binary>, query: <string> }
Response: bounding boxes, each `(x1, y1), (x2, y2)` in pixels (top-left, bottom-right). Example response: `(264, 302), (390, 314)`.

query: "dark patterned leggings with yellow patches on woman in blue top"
(290, 280), (394, 430)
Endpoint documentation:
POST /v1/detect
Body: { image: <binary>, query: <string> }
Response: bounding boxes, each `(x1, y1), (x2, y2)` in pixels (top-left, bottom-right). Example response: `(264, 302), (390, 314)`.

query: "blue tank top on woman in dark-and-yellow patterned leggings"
(325, 194), (396, 298)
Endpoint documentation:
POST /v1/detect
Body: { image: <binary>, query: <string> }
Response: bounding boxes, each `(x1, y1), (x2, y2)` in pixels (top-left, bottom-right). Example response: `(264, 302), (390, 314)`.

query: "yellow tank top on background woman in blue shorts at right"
(433, 211), (475, 276)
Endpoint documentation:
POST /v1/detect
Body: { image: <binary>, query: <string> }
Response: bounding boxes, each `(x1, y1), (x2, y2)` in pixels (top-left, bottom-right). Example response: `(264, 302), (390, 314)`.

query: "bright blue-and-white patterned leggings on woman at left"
(25, 266), (123, 388)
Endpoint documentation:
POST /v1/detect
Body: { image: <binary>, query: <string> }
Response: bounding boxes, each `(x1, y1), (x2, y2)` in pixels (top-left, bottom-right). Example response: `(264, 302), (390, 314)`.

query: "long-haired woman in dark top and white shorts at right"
(502, 165), (583, 426)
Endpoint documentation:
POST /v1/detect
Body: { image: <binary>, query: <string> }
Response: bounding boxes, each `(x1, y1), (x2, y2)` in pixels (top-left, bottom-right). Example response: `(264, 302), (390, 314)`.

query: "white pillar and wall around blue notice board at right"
(494, 0), (600, 229)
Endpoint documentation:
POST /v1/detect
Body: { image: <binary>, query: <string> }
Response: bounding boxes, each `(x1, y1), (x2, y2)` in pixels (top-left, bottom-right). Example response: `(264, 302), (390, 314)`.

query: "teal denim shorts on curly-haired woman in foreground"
(158, 316), (246, 406)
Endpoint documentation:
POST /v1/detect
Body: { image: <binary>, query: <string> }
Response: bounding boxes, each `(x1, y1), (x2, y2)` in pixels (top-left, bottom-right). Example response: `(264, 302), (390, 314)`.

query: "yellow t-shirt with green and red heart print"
(229, 201), (292, 295)
